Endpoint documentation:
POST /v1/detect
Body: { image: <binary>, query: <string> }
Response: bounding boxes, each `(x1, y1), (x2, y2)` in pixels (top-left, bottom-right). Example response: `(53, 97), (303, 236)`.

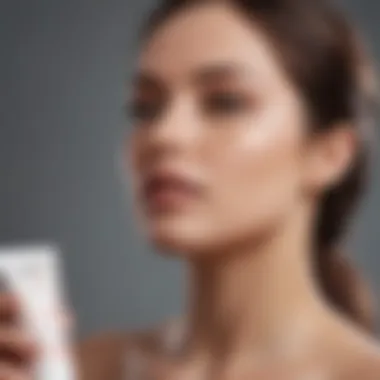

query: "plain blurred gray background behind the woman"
(0, 0), (380, 335)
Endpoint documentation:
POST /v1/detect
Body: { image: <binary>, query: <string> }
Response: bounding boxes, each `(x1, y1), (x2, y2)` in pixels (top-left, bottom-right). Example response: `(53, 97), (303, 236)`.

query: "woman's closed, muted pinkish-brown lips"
(142, 169), (202, 210)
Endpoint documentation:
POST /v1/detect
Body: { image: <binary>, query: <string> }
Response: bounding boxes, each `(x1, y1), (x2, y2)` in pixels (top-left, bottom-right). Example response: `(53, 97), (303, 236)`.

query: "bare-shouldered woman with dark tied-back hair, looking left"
(2, 0), (380, 380)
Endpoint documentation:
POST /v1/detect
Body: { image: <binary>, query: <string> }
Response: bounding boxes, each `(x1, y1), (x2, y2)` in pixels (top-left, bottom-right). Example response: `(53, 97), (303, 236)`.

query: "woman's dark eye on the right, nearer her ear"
(205, 92), (249, 114)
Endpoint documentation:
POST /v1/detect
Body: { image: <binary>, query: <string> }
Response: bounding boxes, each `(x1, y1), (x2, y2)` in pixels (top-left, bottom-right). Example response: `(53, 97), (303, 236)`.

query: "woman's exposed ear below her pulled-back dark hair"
(304, 124), (357, 193)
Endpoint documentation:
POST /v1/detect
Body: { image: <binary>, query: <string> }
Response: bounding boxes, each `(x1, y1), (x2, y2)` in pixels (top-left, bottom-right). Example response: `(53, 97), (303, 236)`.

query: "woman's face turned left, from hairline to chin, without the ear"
(126, 5), (318, 256)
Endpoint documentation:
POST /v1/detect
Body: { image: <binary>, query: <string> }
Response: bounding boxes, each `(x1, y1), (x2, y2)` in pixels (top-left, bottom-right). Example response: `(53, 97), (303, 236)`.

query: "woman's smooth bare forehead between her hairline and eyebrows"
(139, 4), (283, 85)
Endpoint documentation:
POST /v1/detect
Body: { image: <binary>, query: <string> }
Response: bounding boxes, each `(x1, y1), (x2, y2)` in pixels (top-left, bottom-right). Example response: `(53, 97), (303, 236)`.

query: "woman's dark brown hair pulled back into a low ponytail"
(143, 0), (375, 329)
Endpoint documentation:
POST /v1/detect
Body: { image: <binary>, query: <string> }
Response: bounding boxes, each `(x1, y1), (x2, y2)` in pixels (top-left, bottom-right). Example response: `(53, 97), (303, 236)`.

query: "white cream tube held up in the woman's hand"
(0, 245), (76, 380)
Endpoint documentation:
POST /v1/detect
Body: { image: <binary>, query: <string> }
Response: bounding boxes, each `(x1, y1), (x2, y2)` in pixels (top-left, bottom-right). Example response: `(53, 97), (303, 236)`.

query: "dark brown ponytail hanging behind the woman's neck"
(316, 150), (375, 332)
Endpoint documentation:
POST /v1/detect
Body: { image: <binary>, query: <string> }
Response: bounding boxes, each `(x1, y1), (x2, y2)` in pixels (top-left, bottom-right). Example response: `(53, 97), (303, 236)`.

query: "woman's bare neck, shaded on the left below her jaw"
(183, 212), (323, 357)
